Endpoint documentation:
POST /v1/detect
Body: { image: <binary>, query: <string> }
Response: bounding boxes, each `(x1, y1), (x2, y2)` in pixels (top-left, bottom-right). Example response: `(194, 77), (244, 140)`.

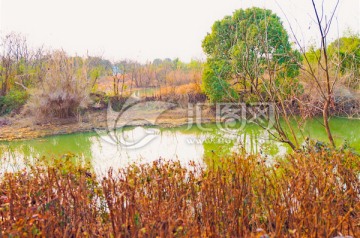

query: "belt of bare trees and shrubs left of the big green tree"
(0, 33), (203, 117)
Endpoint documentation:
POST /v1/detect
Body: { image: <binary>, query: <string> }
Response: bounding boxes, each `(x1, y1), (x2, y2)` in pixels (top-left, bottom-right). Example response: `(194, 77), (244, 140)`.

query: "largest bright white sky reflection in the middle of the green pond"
(91, 128), (204, 177)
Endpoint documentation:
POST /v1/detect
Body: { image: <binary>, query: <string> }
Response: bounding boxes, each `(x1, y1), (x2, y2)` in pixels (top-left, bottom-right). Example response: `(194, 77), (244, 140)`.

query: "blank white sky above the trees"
(0, 0), (360, 62)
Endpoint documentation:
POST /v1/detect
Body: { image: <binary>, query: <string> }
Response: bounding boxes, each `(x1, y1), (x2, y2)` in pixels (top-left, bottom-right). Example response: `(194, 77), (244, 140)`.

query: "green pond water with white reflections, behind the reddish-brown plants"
(0, 118), (360, 173)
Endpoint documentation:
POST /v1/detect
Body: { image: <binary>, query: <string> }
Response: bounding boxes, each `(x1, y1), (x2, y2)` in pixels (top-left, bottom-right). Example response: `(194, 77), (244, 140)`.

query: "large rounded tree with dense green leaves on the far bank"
(202, 8), (300, 101)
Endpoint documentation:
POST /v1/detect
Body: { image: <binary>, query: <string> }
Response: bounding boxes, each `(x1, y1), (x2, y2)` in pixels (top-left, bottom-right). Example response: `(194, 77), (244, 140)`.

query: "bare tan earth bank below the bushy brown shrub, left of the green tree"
(0, 108), (215, 141)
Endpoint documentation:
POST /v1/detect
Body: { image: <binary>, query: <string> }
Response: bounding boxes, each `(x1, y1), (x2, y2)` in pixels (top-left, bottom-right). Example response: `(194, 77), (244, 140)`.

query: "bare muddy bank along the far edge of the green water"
(0, 96), (360, 141)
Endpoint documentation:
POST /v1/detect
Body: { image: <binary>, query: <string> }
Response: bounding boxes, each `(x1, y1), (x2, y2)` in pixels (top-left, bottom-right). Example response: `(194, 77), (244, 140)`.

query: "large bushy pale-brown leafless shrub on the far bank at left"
(27, 51), (90, 119)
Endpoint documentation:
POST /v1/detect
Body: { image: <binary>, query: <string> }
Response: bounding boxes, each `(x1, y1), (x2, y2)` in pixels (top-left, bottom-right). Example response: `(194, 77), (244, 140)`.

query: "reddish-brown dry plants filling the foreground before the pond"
(0, 151), (360, 237)
